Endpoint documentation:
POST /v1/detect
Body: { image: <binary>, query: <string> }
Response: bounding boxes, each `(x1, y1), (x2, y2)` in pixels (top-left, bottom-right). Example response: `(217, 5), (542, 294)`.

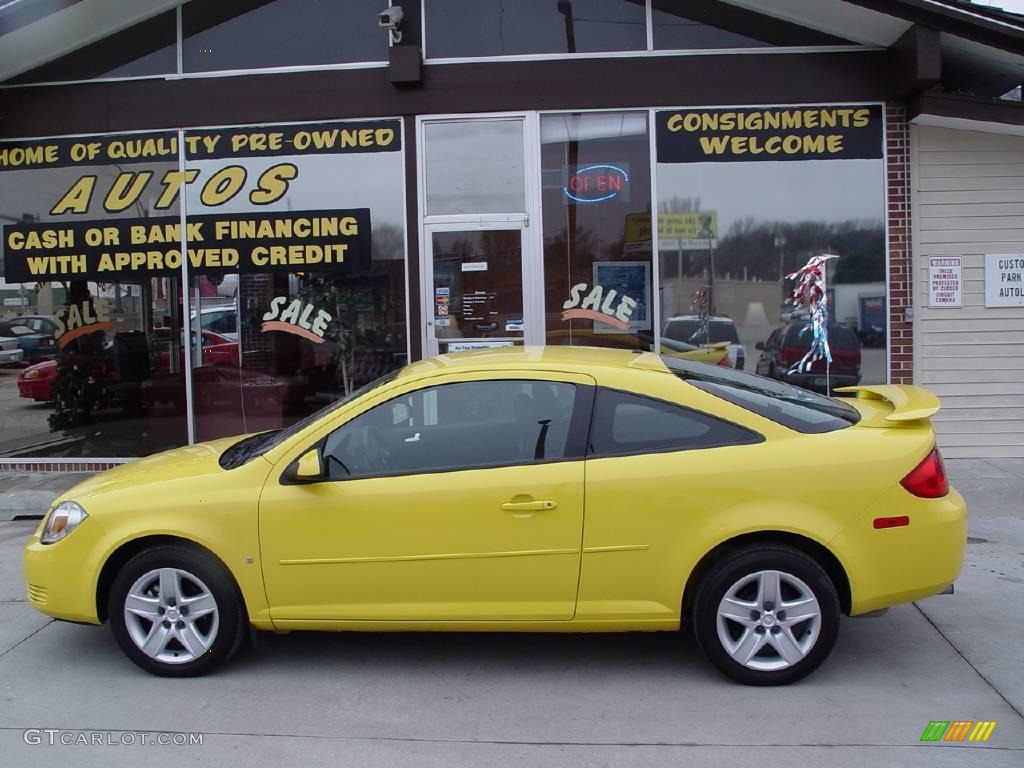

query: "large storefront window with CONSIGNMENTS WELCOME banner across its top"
(656, 105), (887, 390)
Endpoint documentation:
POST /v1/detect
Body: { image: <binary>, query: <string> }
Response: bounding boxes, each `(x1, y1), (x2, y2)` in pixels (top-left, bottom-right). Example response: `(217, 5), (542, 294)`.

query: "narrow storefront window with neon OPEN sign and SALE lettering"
(541, 112), (653, 349)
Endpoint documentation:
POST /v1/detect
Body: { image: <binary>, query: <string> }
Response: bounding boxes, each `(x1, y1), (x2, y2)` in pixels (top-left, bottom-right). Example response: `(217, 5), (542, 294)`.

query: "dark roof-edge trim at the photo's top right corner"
(844, 0), (1024, 53)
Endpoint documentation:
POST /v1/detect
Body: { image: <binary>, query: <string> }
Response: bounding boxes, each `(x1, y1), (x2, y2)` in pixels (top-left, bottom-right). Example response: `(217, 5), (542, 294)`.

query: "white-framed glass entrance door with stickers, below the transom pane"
(424, 224), (539, 354)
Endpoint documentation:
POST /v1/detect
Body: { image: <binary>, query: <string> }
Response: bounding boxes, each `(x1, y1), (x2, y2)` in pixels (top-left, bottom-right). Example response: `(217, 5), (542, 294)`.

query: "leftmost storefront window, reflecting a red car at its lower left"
(0, 133), (188, 458)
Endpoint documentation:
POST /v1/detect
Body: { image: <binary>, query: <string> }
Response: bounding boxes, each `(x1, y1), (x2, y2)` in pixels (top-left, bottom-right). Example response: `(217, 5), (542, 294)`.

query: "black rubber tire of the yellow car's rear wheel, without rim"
(690, 544), (841, 685)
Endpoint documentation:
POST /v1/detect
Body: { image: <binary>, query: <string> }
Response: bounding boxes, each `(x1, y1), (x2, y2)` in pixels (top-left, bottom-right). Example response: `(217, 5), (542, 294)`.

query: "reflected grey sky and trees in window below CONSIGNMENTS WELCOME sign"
(657, 108), (887, 391)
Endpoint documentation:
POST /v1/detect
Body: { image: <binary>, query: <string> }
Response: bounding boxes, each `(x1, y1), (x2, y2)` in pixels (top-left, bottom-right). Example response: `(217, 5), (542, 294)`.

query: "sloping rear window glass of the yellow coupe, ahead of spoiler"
(662, 355), (860, 433)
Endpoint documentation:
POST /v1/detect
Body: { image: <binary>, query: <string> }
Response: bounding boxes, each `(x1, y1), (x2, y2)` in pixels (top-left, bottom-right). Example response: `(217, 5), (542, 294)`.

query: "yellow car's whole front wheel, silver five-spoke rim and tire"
(109, 546), (246, 677)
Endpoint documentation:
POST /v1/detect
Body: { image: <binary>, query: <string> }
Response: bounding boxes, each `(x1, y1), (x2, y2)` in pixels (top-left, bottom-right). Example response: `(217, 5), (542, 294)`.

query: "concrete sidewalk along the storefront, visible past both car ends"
(0, 459), (1024, 521)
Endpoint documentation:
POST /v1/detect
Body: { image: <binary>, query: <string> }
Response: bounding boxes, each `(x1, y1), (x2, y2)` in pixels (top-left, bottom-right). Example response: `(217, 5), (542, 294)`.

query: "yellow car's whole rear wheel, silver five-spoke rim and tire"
(692, 545), (841, 685)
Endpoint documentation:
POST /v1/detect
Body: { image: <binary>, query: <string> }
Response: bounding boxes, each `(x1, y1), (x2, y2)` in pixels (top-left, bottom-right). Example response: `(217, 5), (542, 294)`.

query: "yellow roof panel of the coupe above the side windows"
(398, 345), (668, 379)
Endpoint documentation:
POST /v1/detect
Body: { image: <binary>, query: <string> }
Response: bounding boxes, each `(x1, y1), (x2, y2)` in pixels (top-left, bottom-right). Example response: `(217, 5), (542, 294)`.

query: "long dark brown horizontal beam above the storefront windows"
(0, 51), (899, 138)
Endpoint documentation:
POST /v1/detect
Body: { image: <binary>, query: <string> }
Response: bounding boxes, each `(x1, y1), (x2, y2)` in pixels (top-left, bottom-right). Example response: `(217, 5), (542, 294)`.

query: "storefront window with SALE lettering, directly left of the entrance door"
(184, 120), (408, 440)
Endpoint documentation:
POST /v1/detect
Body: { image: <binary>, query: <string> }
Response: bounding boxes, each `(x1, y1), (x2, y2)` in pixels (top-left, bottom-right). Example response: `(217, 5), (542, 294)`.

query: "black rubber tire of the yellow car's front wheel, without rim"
(108, 545), (249, 677)
